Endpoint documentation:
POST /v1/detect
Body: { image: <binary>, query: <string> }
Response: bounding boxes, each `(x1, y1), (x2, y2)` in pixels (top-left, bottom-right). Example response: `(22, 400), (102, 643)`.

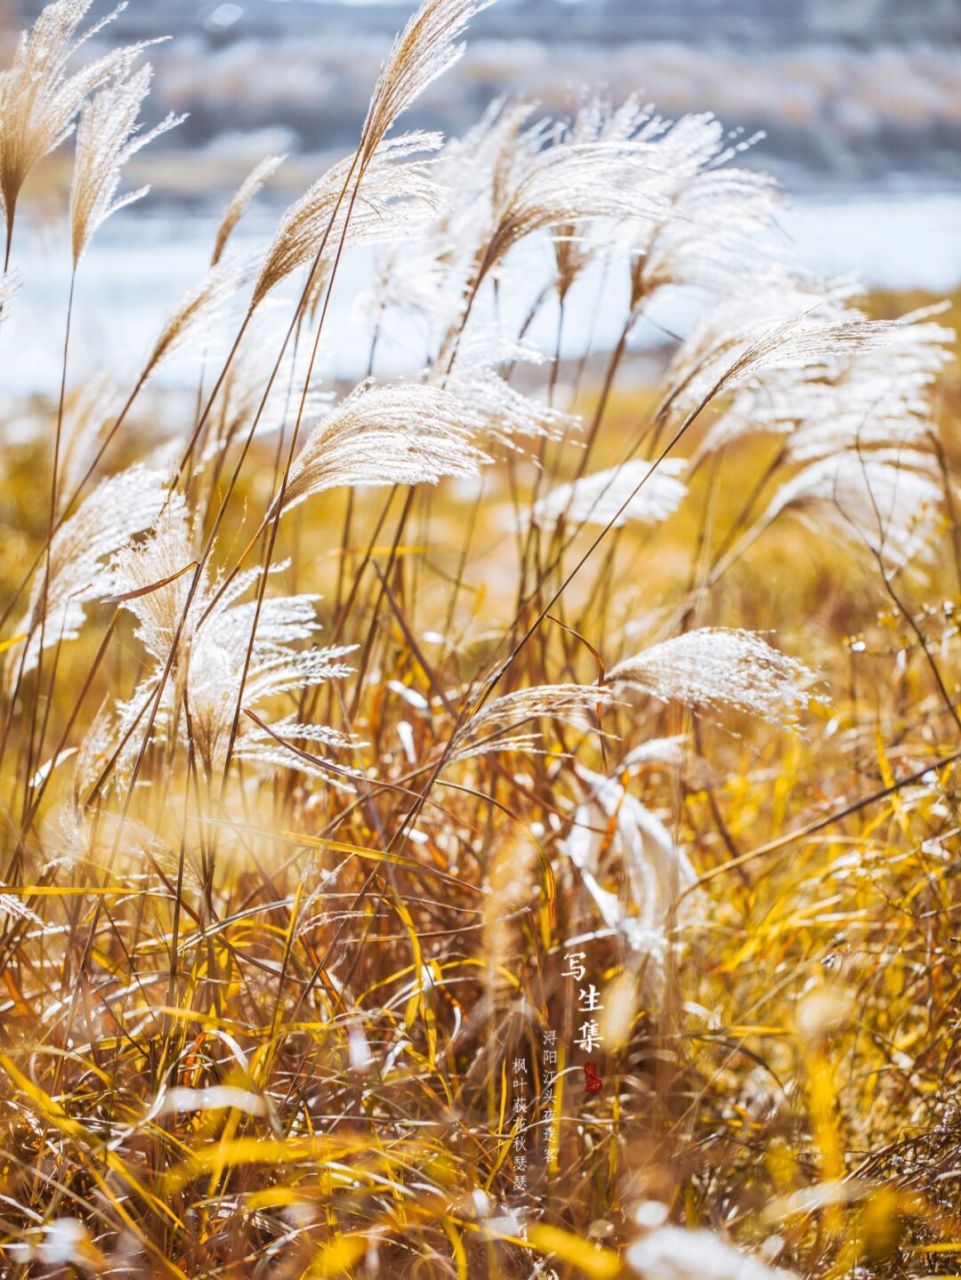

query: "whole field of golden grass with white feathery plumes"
(0, 0), (961, 1280)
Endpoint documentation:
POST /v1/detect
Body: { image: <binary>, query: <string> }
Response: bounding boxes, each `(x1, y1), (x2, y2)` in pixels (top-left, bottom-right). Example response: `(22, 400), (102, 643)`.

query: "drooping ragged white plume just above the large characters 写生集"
(562, 765), (696, 998)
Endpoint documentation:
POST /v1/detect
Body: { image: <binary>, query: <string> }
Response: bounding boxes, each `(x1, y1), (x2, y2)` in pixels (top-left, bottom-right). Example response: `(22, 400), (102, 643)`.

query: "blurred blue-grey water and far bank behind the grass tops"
(0, 0), (961, 394)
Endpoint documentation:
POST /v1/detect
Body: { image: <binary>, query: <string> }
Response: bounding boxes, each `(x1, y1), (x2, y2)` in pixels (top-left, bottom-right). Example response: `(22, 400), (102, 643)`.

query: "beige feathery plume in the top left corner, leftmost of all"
(0, 0), (145, 252)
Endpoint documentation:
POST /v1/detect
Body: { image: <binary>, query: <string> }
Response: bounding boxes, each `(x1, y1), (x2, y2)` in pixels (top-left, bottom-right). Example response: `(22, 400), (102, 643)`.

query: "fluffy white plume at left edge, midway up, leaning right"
(8, 463), (168, 671)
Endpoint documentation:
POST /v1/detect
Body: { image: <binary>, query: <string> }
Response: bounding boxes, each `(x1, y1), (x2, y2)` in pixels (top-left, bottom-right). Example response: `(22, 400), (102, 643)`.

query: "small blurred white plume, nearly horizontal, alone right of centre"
(531, 458), (687, 529)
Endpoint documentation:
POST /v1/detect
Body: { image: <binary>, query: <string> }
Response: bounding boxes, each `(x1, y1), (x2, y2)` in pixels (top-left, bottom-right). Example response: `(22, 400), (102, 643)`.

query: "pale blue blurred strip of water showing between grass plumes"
(0, 193), (961, 398)
